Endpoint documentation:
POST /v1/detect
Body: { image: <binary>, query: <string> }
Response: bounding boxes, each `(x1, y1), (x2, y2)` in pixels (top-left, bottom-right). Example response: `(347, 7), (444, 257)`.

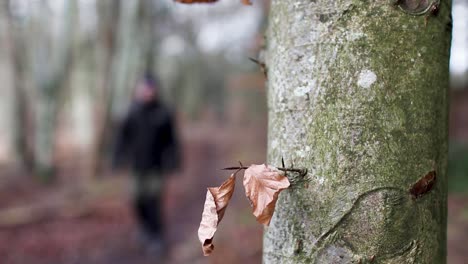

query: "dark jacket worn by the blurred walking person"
(114, 101), (180, 173)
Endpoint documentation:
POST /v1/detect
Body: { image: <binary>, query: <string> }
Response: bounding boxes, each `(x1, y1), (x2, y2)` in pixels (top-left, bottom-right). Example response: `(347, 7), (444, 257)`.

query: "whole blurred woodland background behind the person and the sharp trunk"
(0, 0), (468, 264)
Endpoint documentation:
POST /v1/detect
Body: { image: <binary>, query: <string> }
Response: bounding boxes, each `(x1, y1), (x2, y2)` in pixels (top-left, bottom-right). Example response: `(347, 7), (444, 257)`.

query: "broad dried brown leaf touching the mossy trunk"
(244, 164), (289, 225)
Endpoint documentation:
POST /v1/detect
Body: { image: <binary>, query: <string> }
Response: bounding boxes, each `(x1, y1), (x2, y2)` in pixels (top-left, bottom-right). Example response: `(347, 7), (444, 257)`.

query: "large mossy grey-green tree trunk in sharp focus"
(263, 0), (451, 263)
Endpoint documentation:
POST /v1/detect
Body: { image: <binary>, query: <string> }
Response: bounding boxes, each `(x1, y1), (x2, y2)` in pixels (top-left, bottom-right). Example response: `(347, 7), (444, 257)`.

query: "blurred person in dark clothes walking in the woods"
(114, 74), (180, 253)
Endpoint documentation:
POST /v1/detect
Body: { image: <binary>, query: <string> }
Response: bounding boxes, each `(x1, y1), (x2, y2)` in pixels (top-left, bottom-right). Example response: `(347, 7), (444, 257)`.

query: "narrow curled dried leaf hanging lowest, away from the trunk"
(198, 173), (236, 256)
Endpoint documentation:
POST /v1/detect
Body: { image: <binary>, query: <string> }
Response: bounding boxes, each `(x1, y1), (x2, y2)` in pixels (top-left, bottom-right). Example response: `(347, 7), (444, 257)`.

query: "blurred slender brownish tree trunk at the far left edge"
(3, 1), (34, 171)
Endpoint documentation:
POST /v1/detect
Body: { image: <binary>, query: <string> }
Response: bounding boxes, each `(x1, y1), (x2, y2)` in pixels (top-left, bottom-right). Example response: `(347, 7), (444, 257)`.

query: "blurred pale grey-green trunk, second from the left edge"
(34, 0), (78, 182)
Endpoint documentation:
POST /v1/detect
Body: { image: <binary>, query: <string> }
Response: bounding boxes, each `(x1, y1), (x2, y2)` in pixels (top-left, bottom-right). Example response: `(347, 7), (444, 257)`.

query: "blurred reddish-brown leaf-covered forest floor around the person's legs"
(0, 120), (468, 264)
